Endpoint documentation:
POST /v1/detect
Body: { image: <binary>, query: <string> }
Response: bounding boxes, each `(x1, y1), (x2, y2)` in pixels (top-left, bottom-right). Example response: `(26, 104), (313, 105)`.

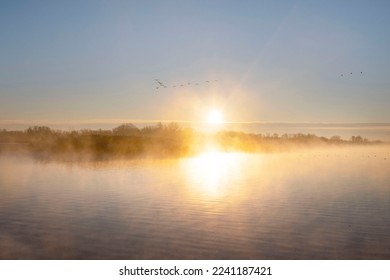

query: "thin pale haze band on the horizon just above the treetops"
(0, 122), (390, 141)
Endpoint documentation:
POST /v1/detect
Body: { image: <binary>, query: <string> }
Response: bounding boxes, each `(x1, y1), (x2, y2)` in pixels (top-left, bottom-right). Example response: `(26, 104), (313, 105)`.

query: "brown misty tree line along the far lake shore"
(0, 122), (380, 157)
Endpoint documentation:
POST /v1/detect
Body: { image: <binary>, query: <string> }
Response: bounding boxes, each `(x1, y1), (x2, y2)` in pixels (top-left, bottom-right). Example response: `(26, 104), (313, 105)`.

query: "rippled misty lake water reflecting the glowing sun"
(0, 147), (390, 259)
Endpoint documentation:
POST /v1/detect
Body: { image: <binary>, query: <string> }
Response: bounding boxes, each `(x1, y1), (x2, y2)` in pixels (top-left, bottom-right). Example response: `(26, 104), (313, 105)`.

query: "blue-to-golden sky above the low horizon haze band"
(0, 0), (390, 127)
